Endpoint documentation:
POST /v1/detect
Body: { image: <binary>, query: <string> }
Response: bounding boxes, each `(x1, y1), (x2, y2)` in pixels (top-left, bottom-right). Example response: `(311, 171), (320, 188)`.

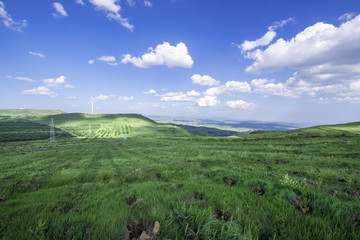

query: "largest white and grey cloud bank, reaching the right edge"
(246, 15), (360, 101)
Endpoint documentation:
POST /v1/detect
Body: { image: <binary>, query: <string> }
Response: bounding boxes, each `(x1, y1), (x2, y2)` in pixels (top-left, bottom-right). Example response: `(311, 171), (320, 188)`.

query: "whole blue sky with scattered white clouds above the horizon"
(0, 0), (360, 123)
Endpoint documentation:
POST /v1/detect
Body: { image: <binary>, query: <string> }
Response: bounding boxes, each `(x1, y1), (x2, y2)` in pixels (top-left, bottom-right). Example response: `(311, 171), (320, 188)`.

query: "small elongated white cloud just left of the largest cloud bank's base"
(204, 81), (251, 96)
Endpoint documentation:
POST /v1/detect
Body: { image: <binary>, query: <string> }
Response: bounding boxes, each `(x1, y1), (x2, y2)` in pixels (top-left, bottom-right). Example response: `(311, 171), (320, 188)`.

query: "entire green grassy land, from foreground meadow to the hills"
(0, 111), (360, 240)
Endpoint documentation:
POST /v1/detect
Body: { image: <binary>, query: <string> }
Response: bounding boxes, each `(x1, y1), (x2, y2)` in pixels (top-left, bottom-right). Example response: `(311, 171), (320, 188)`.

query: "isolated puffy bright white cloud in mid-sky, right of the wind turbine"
(121, 42), (194, 68)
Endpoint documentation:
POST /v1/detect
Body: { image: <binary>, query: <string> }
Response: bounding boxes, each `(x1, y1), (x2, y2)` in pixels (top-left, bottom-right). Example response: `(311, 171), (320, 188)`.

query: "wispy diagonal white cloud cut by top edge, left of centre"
(89, 0), (134, 31)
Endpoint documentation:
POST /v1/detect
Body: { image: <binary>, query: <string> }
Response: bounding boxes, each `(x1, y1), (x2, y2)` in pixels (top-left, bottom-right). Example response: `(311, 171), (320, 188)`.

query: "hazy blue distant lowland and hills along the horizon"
(147, 115), (309, 132)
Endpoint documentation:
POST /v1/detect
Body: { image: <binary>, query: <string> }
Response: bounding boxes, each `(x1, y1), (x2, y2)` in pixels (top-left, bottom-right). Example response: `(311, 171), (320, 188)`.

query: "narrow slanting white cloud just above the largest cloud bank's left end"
(237, 18), (294, 53)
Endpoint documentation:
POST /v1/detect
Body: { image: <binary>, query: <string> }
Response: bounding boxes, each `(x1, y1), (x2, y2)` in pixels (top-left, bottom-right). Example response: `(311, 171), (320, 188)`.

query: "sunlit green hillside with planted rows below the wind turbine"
(31, 113), (189, 138)
